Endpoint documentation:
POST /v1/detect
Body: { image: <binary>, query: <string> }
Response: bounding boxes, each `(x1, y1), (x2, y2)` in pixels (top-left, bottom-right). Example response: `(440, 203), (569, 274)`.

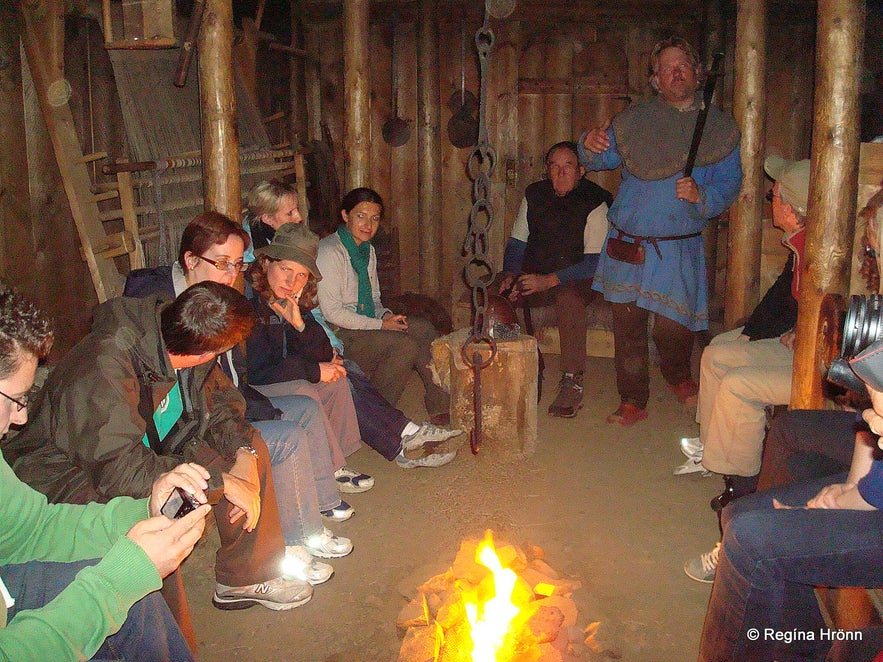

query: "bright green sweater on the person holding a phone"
(0, 455), (162, 662)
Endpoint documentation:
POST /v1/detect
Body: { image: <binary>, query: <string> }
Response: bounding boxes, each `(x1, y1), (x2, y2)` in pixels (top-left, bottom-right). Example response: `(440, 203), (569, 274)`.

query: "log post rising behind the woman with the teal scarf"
(341, 0), (371, 190)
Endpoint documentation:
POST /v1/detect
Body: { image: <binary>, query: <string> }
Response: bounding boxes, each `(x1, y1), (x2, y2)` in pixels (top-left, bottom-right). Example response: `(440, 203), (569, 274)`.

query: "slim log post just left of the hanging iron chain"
(416, 0), (444, 297)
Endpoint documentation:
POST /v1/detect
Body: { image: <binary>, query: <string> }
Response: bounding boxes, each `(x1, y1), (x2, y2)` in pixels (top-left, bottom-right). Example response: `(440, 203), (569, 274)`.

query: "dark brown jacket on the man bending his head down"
(4, 295), (261, 503)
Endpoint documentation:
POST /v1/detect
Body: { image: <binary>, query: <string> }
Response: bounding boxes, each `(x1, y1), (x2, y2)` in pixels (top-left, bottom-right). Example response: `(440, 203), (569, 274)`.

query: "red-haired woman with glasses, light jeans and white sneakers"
(124, 212), (354, 584)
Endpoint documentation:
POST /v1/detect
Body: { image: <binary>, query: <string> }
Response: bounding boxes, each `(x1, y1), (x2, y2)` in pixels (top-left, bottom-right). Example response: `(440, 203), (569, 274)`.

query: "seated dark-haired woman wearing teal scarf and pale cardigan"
(316, 188), (450, 425)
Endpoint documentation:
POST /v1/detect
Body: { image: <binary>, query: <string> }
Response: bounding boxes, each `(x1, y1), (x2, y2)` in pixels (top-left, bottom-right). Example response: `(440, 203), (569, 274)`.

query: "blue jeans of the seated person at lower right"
(699, 474), (883, 662)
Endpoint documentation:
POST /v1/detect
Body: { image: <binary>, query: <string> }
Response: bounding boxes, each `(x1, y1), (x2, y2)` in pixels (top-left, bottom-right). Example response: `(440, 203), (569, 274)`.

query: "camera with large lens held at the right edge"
(828, 294), (883, 396)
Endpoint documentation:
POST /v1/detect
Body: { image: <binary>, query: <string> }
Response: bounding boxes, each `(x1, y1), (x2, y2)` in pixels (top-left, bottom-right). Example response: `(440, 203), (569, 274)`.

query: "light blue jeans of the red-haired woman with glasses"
(253, 418), (324, 545)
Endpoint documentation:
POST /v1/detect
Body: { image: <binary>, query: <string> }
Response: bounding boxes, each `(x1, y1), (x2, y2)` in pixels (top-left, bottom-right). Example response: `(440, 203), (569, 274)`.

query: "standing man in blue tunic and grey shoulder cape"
(579, 37), (742, 426)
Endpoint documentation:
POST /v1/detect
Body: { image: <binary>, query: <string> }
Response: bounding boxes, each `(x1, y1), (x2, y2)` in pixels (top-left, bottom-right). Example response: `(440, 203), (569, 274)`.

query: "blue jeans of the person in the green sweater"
(0, 559), (193, 662)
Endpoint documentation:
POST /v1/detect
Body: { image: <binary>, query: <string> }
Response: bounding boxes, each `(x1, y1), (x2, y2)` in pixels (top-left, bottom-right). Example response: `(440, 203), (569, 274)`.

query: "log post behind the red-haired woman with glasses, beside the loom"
(199, 0), (242, 221)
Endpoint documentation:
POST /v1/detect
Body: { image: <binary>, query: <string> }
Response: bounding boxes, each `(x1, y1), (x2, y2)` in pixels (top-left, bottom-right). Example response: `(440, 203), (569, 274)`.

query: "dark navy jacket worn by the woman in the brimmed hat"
(245, 286), (334, 385)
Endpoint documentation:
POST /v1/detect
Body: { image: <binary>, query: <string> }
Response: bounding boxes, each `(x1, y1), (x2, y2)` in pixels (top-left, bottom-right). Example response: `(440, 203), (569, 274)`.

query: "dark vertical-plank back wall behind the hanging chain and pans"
(304, 9), (720, 305)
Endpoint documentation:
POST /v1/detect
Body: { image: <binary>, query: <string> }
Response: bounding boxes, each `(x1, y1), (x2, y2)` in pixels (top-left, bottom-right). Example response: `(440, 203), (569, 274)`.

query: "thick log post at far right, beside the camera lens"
(791, 0), (864, 409)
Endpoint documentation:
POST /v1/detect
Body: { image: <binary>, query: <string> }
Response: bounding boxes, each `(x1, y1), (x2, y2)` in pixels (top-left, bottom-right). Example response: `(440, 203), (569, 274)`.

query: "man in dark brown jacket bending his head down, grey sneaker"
(6, 282), (313, 626)
